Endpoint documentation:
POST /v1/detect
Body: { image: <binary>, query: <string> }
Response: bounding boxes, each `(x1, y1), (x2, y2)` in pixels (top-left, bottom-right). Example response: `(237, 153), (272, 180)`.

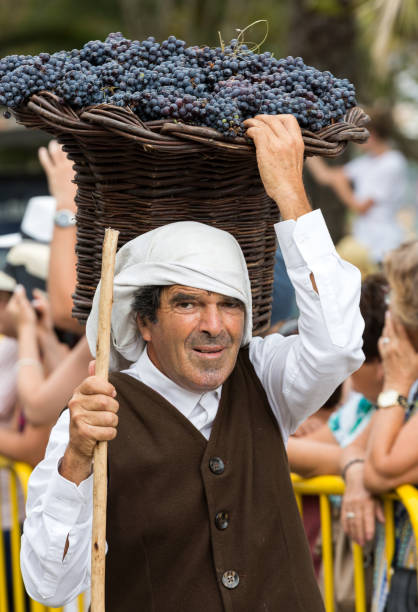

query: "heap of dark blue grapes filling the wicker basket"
(0, 32), (356, 137)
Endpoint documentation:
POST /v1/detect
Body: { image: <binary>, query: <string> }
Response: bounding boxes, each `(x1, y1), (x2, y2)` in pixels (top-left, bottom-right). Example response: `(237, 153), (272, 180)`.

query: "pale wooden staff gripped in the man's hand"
(91, 228), (119, 612)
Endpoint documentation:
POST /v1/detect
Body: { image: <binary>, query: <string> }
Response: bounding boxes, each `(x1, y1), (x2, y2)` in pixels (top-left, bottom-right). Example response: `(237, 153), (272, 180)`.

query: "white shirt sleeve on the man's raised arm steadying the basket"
(249, 210), (364, 443)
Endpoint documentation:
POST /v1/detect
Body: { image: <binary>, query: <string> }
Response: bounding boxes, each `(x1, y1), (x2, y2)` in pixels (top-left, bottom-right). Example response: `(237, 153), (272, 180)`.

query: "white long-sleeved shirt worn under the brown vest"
(21, 210), (364, 606)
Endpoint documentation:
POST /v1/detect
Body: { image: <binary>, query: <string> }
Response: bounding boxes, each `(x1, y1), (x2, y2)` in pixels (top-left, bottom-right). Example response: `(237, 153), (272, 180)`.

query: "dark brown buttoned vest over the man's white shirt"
(106, 349), (324, 612)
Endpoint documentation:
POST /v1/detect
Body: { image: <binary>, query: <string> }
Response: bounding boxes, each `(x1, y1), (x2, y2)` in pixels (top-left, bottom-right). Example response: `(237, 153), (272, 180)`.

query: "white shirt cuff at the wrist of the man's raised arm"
(274, 209), (337, 269)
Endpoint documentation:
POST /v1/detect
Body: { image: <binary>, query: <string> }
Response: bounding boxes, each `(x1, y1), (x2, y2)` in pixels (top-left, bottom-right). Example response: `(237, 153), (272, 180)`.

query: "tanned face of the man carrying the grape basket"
(138, 285), (245, 392)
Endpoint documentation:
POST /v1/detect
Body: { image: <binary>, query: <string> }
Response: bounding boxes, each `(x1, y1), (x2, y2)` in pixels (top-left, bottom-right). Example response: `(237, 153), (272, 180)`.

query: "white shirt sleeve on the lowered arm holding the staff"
(20, 410), (93, 607)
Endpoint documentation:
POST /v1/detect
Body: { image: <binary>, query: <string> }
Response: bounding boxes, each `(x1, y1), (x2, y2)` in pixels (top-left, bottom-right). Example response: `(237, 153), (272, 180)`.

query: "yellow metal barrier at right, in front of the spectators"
(292, 474), (418, 612)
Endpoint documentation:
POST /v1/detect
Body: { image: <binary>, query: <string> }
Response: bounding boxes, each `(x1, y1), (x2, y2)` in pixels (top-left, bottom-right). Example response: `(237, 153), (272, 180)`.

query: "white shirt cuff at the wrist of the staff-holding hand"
(44, 459), (93, 527)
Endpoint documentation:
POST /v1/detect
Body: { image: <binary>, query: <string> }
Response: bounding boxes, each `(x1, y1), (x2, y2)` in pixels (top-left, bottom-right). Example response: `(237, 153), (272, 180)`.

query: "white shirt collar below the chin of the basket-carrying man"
(126, 348), (222, 417)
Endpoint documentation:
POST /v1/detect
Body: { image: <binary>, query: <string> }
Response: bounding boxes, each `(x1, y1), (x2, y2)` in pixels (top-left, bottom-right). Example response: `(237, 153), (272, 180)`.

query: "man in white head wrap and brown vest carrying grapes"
(22, 116), (363, 612)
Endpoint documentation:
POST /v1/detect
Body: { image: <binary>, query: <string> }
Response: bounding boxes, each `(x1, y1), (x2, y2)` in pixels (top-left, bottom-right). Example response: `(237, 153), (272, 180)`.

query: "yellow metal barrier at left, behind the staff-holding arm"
(0, 457), (85, 612)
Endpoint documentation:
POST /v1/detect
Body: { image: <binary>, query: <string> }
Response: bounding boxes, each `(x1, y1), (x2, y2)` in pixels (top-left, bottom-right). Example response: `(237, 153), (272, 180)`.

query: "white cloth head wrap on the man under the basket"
(86, 221), (252, 371)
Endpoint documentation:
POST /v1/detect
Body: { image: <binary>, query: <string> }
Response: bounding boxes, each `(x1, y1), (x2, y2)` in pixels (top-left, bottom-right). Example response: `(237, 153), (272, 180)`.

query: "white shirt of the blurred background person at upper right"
(344, 151), (407, 262)
